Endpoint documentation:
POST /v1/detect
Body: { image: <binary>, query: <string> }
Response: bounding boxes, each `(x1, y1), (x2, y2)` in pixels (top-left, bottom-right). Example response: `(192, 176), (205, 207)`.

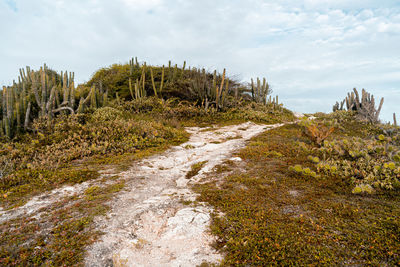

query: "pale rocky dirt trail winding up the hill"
(85, 122), (281, 266)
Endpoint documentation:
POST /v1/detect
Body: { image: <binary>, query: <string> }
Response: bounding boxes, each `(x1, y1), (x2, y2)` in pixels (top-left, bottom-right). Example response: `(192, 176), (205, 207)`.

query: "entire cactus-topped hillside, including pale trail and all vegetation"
(0, 59), (400, 266)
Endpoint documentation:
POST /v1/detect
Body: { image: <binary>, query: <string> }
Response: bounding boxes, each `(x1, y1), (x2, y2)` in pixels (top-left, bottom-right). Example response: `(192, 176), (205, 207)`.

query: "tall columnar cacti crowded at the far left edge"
(0, 64), (107, 139)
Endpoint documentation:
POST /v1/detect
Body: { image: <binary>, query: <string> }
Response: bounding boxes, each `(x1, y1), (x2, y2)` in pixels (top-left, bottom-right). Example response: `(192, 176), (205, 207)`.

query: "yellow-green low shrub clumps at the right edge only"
(317, 134), (400, 193)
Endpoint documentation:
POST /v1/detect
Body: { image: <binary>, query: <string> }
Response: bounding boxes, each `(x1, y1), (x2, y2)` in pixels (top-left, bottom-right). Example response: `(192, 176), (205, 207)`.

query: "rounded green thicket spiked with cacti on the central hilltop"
(85, 59), (279, 111)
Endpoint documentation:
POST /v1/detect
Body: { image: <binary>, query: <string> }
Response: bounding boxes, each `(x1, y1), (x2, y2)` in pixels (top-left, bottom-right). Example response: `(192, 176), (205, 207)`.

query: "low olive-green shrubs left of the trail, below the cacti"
(0, 107), (186, 207)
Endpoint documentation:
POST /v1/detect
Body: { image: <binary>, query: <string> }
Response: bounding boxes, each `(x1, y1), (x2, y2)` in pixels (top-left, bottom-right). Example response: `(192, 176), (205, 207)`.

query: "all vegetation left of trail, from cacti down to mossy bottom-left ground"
(0, 60), (294, 266)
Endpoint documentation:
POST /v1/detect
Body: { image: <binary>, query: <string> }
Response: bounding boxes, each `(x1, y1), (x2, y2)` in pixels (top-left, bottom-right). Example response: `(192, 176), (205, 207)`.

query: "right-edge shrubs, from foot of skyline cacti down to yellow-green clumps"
(298, 116), (400, 193)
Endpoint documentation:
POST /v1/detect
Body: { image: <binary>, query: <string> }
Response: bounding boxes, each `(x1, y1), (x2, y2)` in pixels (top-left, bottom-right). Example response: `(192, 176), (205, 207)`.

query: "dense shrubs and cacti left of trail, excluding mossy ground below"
(0, 59), (292, 207)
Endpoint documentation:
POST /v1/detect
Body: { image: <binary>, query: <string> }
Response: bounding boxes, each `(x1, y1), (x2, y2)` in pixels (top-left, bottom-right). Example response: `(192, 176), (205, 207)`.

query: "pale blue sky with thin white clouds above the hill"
(0, 0), (400, 121)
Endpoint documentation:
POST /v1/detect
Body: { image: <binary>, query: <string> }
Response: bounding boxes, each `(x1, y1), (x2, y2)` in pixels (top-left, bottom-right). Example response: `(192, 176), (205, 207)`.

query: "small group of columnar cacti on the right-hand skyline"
(333, 88), (384, 123)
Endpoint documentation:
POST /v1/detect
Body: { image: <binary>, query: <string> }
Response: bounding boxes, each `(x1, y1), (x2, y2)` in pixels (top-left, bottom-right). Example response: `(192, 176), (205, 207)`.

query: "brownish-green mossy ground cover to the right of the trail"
(195, 121), (400, 266)
